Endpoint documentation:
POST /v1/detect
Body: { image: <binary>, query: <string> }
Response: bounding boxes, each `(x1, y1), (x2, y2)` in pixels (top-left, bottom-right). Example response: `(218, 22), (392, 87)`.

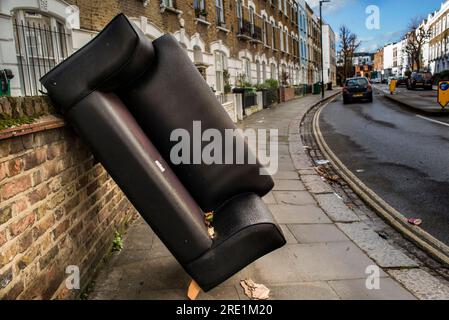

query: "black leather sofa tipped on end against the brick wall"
(41, 15), (285, 291)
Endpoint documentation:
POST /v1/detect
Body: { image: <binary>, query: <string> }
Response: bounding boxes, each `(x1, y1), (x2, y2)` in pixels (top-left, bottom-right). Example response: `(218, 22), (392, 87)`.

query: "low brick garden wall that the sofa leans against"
(0, 98), (135, 299)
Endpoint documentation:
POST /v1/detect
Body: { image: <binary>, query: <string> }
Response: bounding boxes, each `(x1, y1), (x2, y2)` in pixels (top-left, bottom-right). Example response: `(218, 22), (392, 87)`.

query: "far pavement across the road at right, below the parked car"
(374, 84), (449, 115)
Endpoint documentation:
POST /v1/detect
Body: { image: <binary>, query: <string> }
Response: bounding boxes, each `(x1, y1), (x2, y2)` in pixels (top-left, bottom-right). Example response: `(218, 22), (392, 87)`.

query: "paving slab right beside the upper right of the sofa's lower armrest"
(268, 205), (332, 224)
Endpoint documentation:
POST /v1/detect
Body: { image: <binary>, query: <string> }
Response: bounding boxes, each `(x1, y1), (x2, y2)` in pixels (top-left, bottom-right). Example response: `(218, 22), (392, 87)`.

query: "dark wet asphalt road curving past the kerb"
(320, 91), (449, 244)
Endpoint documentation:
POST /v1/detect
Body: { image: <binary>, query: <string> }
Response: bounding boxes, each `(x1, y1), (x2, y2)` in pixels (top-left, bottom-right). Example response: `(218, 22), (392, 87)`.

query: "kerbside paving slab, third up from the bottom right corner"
(315, 194), (360, 222)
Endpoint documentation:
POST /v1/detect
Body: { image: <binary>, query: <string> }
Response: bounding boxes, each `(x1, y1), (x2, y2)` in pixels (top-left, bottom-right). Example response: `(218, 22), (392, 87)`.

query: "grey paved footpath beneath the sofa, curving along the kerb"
(88, 91), (449, 300)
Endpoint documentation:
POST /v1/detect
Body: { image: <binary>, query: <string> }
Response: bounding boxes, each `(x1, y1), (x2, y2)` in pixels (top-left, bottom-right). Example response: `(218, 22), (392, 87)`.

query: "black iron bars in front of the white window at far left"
(13, 21), (69, 96)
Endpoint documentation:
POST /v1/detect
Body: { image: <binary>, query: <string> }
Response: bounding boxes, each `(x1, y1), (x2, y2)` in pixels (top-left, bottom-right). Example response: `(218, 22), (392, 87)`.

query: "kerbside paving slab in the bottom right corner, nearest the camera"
(388, 269), (449, 300)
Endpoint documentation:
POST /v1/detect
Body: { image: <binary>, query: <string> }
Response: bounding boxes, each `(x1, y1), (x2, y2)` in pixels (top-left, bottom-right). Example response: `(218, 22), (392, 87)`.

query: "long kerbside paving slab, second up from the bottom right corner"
(337, 222), (418, 268)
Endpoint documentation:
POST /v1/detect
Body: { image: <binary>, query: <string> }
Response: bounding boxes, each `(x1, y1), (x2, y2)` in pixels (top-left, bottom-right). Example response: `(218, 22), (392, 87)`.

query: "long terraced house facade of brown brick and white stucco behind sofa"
(0, 0), (321, 95)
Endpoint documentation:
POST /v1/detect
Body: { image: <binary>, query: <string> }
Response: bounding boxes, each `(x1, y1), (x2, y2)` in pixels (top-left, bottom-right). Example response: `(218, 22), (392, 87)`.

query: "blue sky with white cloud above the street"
(306, 0), (444, 52)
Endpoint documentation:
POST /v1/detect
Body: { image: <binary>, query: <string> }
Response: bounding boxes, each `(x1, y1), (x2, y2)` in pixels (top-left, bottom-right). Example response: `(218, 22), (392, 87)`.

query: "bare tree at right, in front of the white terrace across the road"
(404, 17), (431, 70)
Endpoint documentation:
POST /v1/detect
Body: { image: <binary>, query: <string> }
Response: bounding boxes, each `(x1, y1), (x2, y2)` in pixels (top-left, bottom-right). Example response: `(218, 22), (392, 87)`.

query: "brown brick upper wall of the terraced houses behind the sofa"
(67, 0), (299, 70)
